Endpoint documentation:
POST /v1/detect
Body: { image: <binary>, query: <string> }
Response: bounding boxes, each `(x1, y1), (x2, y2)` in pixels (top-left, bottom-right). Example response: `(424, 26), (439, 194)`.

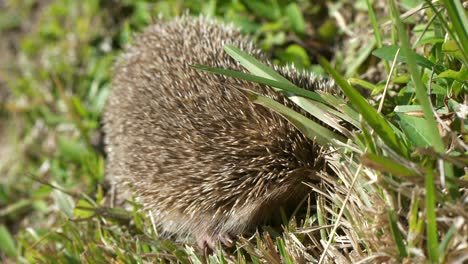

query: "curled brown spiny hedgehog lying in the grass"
(103, 16), (333, 250)
